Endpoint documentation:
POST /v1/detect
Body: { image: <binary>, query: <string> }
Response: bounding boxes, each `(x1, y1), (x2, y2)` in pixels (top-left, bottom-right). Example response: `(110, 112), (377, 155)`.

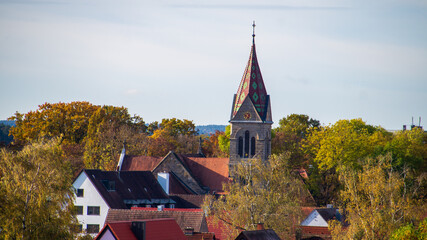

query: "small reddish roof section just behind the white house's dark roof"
(122, 155), (163, 171)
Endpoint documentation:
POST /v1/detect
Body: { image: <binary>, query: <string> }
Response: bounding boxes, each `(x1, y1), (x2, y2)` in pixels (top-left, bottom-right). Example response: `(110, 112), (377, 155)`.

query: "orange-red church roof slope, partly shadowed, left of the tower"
(182, 157), (230, 192)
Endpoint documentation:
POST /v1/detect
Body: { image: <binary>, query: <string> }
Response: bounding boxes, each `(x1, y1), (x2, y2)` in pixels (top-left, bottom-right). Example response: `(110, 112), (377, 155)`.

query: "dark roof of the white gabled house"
(83, 169), (175, 209)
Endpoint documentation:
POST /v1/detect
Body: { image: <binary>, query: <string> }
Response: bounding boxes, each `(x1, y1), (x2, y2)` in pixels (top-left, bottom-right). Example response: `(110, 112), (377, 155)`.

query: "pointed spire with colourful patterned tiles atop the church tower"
(232, 21), (268, 121)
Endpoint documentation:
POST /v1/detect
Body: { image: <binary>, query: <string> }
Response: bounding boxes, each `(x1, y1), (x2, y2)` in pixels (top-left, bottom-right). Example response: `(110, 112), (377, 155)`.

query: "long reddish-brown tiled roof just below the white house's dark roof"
(105, 208), (208, 232)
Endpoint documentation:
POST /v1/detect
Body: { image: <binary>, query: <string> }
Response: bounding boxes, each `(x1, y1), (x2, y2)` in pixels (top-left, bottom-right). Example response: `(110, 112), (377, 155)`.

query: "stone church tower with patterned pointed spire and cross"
(230, 22), (273, 170)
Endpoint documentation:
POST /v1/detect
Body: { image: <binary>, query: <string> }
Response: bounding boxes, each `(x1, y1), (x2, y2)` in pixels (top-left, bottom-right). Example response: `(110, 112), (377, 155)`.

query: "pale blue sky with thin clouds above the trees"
(0, 0), (427, 129)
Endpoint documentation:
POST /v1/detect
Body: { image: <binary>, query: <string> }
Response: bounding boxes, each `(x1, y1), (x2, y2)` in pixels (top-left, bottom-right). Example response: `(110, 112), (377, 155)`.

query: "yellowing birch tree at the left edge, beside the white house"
(0, 138), (76, 239)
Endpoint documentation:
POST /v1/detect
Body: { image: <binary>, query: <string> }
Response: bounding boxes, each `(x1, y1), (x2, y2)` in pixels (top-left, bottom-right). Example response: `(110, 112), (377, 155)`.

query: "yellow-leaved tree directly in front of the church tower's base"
(204, 154), (307, 239)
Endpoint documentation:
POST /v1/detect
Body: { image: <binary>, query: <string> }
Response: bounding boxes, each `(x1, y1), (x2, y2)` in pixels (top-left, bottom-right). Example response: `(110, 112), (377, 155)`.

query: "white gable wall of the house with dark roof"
(73, 172), (109, 235)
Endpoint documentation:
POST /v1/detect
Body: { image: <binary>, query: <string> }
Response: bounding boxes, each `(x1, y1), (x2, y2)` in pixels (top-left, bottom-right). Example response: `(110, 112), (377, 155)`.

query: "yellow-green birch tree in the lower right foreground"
(332, 154), (425, 239)
